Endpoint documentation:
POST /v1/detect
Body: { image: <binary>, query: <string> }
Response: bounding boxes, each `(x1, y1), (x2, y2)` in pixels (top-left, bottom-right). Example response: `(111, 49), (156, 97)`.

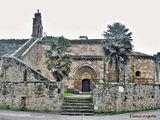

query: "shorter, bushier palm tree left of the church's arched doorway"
(46, 36), (72, 81)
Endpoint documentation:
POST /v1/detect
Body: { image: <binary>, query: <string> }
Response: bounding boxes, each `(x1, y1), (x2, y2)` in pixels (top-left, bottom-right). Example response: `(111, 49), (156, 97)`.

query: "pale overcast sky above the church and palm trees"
(0, 0), (160, 55)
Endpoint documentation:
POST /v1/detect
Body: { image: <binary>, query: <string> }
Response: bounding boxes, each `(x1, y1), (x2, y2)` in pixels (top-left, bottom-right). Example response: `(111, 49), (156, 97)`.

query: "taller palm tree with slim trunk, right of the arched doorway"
(102, 23), (133, 83)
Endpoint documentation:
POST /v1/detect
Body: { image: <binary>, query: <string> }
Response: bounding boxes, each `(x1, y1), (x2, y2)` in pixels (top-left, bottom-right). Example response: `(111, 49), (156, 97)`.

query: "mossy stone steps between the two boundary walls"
(61, 95), (94, 116)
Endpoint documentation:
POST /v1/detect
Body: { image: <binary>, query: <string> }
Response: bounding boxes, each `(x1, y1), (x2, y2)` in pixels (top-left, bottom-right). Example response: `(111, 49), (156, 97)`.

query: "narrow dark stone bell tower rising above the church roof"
(31, 9), (43, 38)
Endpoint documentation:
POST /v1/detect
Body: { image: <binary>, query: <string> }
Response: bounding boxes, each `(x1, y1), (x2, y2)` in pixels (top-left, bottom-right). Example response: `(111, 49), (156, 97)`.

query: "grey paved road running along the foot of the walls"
(0, 110), (160, 120)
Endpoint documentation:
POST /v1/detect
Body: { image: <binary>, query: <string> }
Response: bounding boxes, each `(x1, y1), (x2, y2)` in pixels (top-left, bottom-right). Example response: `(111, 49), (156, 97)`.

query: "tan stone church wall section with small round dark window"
(130, 56), (156, 84)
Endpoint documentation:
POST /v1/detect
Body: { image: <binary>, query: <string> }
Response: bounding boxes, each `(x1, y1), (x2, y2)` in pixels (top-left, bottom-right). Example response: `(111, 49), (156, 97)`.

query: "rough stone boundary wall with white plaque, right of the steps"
(93, 83), (160, 112)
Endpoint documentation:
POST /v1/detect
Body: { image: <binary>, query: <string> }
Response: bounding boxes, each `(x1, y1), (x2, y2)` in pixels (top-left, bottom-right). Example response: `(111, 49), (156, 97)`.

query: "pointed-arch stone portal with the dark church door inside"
(73, 65), (100, 92)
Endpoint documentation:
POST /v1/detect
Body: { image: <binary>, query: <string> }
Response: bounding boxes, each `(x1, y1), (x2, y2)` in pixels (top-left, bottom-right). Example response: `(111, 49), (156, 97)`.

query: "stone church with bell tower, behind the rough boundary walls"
(0, 11), (160, 92)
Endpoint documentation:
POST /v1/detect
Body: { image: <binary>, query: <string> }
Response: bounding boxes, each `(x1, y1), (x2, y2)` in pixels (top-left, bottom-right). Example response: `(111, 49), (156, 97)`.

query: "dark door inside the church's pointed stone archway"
(82, 79), (90, 92)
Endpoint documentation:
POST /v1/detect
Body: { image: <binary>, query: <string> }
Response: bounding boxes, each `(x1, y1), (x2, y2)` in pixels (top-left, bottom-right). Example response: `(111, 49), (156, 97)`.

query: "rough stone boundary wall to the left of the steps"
(0, 81), (64, 112)
